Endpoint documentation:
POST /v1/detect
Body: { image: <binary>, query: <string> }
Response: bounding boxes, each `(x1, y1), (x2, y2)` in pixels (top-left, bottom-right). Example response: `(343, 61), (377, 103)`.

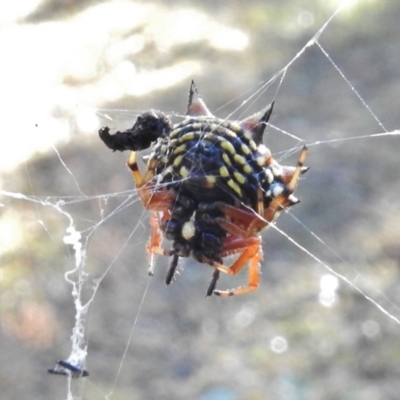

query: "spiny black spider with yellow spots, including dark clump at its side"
(99, 81), (308, 296)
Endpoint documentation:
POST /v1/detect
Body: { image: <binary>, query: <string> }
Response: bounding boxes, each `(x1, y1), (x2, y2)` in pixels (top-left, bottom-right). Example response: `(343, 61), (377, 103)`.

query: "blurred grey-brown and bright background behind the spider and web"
(0, 0), (400, 400)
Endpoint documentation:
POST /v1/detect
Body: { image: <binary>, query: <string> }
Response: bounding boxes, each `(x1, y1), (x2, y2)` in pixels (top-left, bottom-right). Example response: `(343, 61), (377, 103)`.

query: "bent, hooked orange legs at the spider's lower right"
(209, 235), (262, 297)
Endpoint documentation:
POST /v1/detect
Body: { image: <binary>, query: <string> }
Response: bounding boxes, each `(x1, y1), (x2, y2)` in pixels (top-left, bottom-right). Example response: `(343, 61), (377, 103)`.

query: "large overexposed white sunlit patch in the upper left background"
(0, 0), (249, 170)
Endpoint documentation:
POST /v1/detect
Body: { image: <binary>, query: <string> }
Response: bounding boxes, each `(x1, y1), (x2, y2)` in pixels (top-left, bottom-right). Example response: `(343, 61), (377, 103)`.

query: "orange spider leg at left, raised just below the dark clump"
(128, 151), (175, 211)
